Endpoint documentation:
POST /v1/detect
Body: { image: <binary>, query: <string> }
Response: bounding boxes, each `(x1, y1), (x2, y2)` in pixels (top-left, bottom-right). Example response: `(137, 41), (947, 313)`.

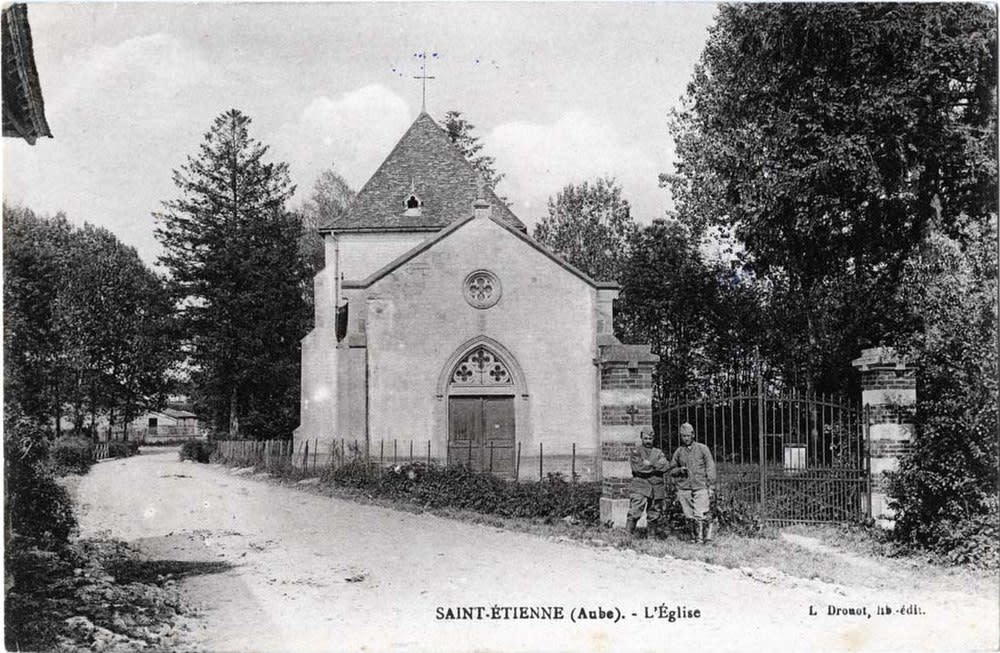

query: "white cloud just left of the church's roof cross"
(273, 84), (413, 198)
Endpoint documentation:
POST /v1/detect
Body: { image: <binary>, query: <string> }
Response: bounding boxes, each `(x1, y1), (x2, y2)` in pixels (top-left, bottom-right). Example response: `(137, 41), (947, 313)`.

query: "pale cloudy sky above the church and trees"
(3, 2), (716, 264)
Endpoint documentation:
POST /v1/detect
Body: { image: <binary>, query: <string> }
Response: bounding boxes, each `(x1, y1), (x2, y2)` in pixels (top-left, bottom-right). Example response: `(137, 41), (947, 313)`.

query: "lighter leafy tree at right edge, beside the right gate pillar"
(890, 223), (1000, 568)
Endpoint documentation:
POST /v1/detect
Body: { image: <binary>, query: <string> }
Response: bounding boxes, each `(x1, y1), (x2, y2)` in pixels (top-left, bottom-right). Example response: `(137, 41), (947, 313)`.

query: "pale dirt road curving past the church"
(78, 450), (998, 652)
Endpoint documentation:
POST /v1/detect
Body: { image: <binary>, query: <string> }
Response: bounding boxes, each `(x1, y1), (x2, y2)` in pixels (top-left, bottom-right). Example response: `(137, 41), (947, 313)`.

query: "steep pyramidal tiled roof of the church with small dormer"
(321, 112), (525, 232)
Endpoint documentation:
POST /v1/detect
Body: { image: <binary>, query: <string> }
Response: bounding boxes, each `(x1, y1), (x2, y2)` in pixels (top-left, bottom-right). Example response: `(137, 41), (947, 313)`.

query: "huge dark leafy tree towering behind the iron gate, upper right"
(664, 4), (997, 390)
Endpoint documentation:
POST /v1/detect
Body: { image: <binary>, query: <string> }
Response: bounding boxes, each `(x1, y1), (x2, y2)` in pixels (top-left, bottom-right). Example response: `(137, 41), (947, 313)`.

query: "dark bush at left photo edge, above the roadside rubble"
(4, 416), (76, 543)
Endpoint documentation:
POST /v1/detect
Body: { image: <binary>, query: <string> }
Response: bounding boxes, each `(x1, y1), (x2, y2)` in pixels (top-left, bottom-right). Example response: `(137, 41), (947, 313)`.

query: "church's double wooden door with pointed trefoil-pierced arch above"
(448, 346), (516, 474)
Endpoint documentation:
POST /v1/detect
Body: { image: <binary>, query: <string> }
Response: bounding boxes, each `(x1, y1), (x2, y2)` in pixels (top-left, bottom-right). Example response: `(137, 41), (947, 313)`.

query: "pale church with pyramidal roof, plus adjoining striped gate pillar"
(295, 111), (656, 502)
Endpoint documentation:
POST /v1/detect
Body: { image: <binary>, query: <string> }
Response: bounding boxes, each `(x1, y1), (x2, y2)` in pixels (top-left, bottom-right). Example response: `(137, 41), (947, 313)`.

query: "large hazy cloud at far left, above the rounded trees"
(4, 34), (219, 262)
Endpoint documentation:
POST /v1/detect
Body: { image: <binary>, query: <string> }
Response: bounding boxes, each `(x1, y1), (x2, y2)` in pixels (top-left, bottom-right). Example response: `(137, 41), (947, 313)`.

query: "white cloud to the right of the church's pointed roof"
(483, 110), (664, 230)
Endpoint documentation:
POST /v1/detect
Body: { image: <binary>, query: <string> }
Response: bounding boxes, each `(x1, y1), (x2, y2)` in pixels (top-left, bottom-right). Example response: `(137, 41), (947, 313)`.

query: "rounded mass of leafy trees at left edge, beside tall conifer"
(4, 206), (176, 433)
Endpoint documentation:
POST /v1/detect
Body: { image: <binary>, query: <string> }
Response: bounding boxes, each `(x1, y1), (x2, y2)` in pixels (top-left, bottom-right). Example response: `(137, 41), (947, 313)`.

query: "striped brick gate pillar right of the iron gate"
(852, 347), (917, 528)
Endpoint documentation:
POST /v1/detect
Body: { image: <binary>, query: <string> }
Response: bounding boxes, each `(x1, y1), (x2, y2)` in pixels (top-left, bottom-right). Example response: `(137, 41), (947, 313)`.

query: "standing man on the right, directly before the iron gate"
(667, 422), (715, 542)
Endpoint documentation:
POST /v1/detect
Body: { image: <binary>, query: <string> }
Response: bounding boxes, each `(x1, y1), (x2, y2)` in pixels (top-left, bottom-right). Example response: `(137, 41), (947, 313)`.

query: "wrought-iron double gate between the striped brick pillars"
(653, 383), (871, 523)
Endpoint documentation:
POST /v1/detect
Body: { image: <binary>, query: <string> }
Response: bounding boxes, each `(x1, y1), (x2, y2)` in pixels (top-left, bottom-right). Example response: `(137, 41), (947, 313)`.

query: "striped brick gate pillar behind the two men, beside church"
(600, 340), (659, 528)
